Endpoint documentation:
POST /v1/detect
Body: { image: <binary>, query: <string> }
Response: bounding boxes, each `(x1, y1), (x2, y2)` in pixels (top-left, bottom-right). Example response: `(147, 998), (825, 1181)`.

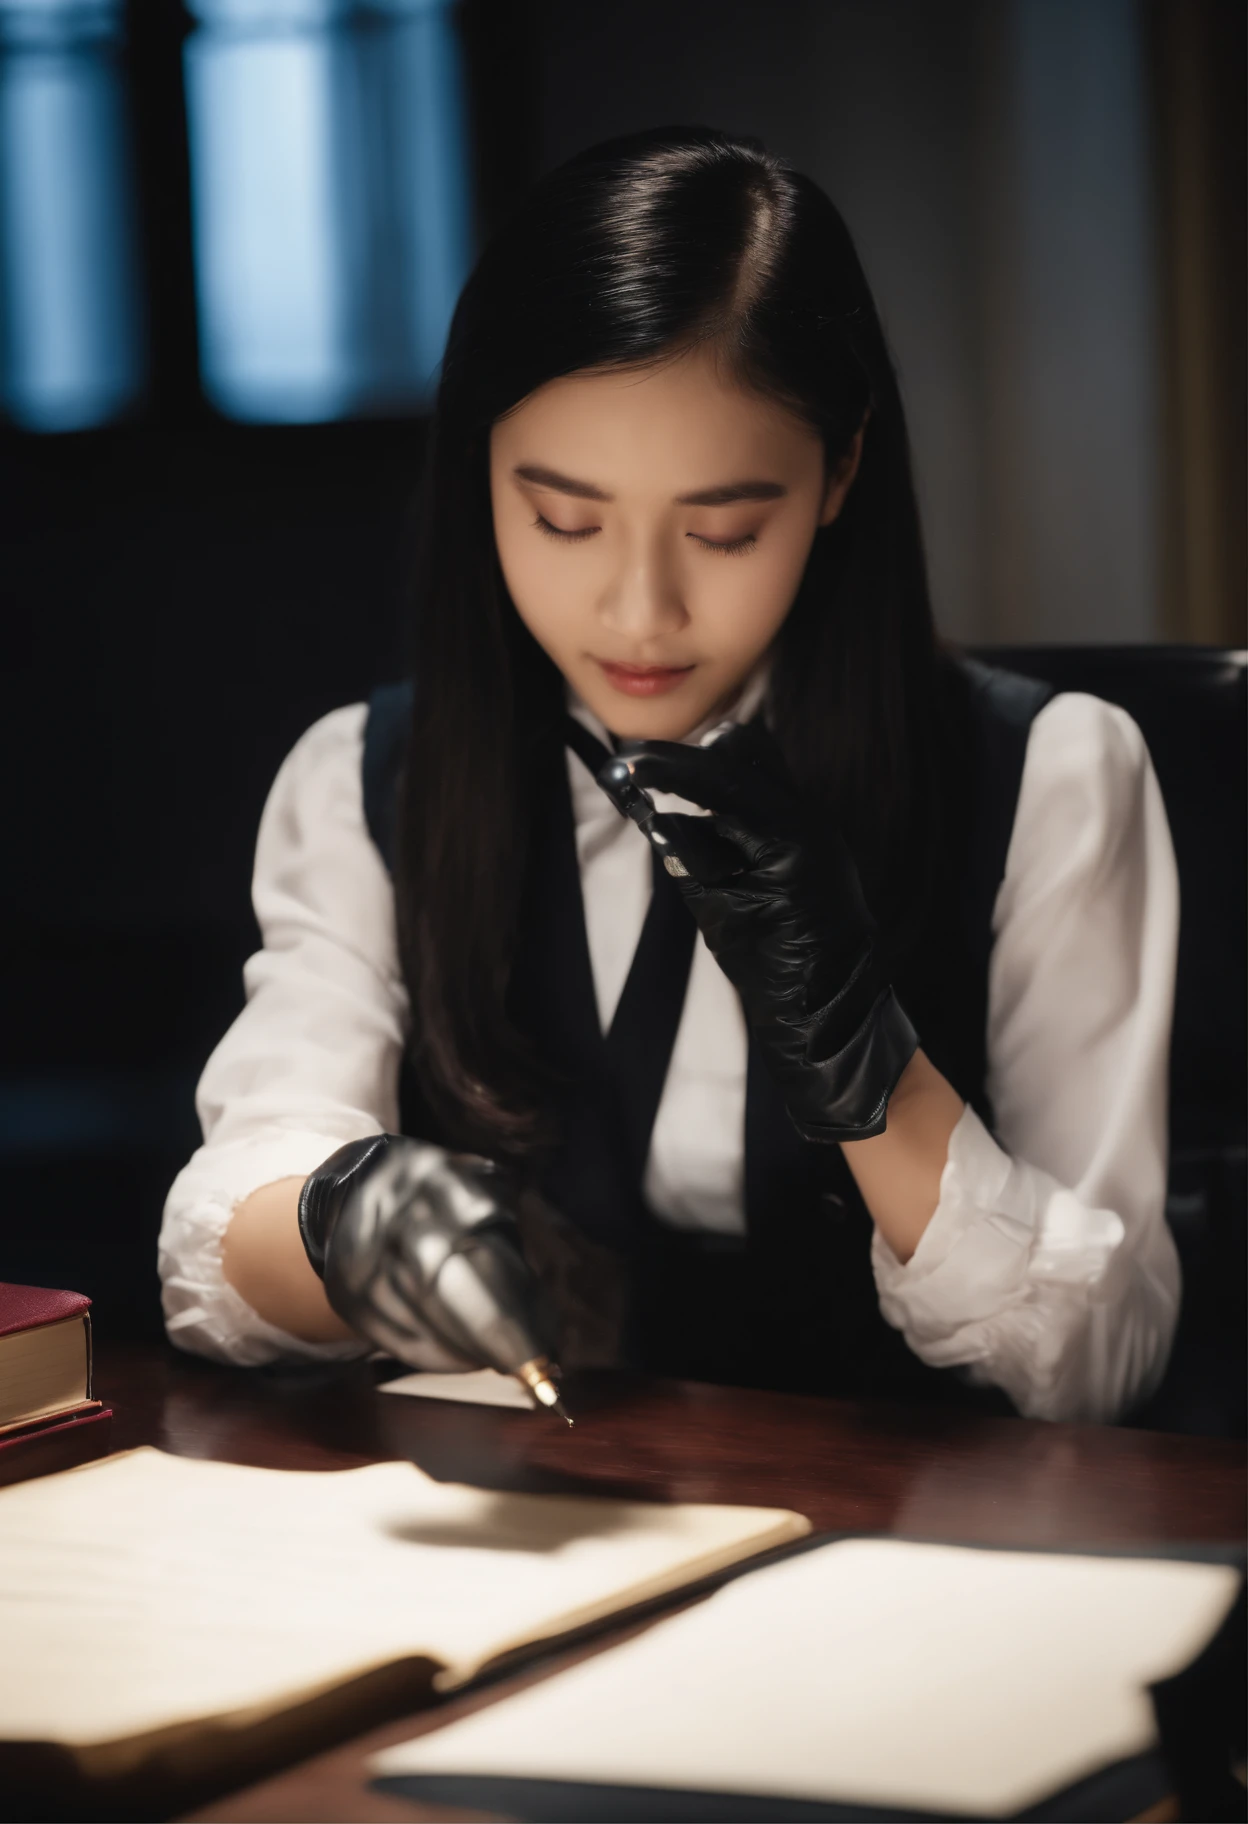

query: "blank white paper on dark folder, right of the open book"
(372, 1539), (1239, 1817)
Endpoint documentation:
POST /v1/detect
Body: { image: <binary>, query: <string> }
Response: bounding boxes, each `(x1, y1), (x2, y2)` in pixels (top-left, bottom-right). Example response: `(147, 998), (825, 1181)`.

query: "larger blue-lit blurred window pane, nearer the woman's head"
(186, 0), (471, 423)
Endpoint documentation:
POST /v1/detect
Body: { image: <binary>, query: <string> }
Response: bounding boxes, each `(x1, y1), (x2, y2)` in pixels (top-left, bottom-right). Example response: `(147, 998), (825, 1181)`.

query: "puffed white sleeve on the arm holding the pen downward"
(159, 704), (407, 1366)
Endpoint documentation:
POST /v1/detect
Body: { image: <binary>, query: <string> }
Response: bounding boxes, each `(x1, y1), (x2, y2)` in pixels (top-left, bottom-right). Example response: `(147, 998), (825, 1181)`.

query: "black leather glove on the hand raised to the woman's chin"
(598, 722), (918, 1140)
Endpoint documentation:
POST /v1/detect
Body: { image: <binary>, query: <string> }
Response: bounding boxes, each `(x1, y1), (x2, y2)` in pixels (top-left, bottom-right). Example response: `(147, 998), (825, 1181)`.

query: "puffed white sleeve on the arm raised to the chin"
(872, 693), (1179, 1421)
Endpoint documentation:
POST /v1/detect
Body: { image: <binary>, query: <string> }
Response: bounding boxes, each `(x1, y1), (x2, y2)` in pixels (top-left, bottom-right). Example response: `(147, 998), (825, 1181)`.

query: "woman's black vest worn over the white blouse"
(363, 660), (1051, 1412)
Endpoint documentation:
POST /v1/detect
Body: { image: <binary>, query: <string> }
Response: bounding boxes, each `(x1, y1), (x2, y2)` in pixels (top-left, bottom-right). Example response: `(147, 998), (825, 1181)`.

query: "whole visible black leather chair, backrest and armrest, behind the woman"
(976, 646), (1248, 1435)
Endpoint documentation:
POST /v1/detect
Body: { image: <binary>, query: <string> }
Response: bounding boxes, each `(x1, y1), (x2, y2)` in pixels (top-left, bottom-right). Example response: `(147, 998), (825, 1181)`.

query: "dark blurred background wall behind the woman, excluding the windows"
(0, 0), (1244, 1328)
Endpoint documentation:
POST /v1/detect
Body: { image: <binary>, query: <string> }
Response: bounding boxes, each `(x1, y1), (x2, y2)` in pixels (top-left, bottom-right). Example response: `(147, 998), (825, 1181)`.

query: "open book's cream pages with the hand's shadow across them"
(0, 1448), (810, 1746)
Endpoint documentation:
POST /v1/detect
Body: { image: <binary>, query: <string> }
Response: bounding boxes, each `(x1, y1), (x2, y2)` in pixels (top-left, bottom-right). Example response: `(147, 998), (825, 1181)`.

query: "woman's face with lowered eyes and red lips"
(489, 350), (859, 741)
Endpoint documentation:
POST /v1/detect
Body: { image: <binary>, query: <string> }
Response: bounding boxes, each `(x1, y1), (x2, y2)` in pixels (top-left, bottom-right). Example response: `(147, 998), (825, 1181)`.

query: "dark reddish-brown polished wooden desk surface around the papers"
(95, 1342), (1246, 1820)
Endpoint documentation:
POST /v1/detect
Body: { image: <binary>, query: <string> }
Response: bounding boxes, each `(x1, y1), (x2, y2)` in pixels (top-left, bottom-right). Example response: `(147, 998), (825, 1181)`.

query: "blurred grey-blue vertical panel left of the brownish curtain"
(983, 0), (1160, 642)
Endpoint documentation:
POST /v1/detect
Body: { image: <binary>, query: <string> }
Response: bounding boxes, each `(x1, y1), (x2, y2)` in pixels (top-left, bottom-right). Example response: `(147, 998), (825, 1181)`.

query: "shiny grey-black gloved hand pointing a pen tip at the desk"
(299, 1135), (558, 1406)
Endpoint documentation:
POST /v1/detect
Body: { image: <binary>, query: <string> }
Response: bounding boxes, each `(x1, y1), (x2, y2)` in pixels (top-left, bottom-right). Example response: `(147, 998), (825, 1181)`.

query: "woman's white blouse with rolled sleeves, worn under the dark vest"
(159, 680), (1179, 1421)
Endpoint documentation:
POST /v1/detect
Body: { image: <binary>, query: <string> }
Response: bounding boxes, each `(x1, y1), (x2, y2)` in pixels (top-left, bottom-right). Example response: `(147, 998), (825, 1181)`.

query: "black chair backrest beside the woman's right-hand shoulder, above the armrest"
(978, 646), (1248, 1153)
